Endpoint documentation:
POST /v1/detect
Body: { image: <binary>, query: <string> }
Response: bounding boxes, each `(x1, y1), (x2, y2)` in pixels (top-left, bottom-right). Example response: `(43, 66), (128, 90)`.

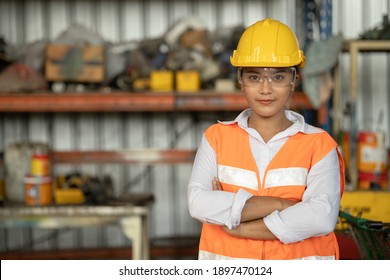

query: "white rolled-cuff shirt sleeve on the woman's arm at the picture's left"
(188, 135), (252, 228)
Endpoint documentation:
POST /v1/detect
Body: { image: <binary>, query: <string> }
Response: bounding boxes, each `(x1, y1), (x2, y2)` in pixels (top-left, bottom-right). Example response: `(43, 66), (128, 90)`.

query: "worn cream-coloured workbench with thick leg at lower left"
(0, 196), (152, 260)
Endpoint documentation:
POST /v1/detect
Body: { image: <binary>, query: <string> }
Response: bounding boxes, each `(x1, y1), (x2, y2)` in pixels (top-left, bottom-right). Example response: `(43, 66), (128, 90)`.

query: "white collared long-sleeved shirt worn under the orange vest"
(188, 109), (340, 243)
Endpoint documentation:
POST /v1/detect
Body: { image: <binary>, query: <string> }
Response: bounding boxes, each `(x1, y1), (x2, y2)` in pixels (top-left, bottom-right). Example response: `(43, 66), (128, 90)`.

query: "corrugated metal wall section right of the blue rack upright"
(333, 0), (390, 141)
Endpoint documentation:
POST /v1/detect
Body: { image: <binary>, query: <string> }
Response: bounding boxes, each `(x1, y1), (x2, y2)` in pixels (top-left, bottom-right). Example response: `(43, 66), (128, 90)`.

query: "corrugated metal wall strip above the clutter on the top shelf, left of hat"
(0, 0), (294, 45)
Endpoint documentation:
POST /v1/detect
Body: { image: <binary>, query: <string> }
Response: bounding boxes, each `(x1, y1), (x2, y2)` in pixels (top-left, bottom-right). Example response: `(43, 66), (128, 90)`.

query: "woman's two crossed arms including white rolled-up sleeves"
(188, 135), (341, 244)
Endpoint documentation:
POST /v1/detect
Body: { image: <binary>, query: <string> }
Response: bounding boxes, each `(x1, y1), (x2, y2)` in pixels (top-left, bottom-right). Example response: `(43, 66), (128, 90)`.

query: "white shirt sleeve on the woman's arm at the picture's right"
(264, 148), (340, 244)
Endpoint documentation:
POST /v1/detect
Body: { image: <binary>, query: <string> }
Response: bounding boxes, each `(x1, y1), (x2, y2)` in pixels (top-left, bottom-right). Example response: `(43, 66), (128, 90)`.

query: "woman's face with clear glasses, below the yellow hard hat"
(238, 67), (296, 118)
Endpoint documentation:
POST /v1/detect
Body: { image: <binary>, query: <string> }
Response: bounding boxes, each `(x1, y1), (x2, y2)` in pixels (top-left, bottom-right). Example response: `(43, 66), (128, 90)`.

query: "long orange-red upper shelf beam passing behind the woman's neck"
(0, 90), (313, 112)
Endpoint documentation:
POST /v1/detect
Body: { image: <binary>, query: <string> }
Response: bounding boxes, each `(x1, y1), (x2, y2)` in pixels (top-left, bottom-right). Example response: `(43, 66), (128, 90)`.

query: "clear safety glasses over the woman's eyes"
(238, 67), (296, 87)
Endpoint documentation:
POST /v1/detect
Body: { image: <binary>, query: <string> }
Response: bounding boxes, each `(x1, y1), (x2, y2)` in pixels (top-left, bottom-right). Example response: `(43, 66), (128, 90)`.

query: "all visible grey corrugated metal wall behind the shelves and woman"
(0, 0), (390, 254)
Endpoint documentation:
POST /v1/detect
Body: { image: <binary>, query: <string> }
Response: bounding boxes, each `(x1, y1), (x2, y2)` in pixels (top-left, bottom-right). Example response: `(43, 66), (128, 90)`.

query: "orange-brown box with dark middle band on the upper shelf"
(45, 44), (104, 83)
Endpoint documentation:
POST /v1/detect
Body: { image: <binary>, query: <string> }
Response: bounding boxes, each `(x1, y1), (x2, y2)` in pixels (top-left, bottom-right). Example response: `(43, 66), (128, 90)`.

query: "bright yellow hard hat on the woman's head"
(230, 18), (306, 68)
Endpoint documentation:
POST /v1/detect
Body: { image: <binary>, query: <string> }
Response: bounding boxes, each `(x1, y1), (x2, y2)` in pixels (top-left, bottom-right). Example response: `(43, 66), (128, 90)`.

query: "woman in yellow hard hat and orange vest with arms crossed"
(188, 18), (344, 259)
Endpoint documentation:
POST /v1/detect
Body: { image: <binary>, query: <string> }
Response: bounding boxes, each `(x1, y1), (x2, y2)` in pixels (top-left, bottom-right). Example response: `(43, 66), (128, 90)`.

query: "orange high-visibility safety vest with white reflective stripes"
(199, 123), (344, 260)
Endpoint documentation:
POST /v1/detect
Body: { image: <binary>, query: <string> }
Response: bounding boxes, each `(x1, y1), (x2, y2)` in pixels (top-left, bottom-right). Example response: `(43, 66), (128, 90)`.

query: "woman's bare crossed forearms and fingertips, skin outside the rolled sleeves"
(212, 178), (297, 240)
